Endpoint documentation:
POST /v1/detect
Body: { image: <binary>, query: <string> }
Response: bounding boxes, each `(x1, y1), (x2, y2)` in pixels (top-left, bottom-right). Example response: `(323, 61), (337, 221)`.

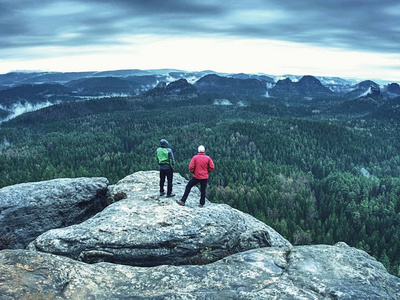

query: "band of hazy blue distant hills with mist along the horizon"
(0, 69), (400, 121)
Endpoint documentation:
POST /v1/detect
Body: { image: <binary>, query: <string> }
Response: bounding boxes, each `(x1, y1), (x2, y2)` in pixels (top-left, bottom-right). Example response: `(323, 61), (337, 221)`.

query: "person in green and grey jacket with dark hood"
(156, 139), (175, 197)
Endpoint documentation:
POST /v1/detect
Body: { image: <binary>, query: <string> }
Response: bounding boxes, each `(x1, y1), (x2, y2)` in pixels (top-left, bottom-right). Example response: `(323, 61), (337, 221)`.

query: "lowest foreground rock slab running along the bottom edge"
(0, 243), (400, 300)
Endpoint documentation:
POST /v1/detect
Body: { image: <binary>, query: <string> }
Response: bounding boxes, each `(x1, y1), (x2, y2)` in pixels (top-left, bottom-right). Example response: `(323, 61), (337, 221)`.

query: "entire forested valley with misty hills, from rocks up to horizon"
(0, 70), (400, 276)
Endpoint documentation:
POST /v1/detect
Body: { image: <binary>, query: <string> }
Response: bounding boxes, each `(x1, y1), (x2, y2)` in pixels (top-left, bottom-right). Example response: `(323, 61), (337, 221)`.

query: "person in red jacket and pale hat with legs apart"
(176, 145), (214, 207)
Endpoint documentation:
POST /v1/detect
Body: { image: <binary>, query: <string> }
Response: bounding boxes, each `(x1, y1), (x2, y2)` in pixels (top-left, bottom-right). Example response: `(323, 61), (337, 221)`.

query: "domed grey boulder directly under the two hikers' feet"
(29, 171), (291, 266)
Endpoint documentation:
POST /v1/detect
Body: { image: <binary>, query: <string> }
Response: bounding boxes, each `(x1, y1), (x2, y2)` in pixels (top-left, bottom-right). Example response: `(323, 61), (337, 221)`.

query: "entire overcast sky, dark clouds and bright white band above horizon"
(0, 0), (400, 82)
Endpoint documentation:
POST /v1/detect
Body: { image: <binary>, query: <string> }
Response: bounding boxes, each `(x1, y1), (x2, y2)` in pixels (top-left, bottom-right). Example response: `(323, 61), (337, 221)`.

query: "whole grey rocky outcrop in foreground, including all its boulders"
(0, 171), (400, 300)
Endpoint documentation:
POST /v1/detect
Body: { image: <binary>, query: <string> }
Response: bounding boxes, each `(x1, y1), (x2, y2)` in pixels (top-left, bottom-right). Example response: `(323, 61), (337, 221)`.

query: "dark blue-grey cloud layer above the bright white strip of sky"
(0, 0), (400, 56)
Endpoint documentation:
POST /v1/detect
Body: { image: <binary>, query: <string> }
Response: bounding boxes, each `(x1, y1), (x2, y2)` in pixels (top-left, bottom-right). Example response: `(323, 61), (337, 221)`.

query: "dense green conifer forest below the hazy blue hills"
(0, 94), (400, 276)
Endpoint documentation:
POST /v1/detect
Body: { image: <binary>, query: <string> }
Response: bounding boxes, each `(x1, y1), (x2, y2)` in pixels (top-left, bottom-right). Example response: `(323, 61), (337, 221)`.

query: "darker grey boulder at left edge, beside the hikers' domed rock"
(0, 178), (108, 249)
